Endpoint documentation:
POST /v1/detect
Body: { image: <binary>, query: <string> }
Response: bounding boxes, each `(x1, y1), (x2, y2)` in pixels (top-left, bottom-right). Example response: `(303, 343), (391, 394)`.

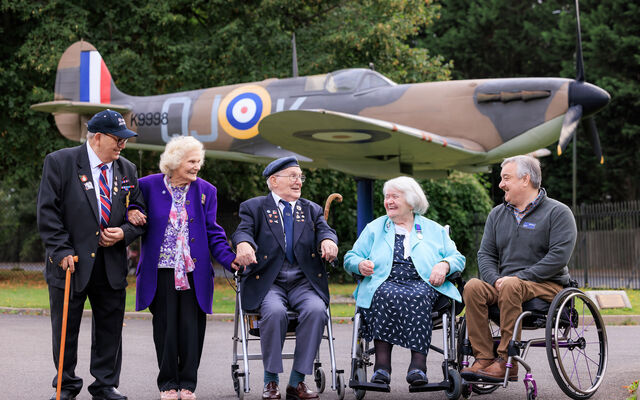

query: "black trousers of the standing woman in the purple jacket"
(149, 268), (207, 392)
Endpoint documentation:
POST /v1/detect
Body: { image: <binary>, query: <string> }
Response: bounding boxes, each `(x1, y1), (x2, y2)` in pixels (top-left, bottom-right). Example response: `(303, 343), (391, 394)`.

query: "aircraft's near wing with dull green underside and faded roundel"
(259, 110), (486, 178)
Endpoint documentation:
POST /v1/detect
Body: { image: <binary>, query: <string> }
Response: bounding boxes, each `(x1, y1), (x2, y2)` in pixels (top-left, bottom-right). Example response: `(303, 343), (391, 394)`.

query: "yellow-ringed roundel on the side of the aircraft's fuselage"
(218, 85), (271, 139)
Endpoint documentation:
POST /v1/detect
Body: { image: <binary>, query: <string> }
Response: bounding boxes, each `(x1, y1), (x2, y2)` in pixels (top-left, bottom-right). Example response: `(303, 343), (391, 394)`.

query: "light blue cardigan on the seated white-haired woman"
(344, 215), (465, 308)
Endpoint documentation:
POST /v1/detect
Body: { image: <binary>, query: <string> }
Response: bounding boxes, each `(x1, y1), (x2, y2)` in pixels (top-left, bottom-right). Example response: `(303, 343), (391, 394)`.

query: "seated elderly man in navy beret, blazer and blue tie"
(232, 157), (338, 399)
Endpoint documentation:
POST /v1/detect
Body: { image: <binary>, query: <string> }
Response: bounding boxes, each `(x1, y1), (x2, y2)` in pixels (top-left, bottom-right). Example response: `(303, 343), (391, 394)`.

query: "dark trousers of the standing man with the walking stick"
(49, 249), (126, 393)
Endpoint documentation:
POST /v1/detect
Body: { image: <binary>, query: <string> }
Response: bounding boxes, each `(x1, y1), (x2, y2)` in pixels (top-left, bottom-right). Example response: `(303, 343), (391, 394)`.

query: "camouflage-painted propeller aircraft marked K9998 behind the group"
(32, 41), (609, 179)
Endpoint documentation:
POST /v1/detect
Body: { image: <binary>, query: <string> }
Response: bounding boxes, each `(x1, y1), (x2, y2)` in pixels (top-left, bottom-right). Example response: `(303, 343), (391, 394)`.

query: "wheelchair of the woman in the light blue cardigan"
(349, 272), (464, 400)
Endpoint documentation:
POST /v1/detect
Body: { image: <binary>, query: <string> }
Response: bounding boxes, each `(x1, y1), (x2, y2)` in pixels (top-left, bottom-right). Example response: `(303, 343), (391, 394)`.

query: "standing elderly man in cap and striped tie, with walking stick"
(38, 110), (144, 400)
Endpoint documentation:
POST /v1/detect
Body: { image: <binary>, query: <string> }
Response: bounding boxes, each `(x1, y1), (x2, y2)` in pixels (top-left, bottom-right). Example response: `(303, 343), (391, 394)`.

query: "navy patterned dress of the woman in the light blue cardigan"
(360, 235), (440, 354)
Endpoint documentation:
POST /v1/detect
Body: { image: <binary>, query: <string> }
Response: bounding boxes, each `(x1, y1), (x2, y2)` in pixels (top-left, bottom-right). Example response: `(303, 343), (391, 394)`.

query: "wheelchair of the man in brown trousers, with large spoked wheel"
(457, 280), (607, 400)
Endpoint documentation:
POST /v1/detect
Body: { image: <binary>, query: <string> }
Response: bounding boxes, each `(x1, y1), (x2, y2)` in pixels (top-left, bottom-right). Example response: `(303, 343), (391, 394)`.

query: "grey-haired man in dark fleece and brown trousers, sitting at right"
(461, 156), (577, 382)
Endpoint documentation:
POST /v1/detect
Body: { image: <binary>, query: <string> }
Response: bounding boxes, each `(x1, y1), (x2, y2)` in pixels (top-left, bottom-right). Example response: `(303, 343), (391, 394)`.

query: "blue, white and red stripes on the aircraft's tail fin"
(80, 50), (111, 103)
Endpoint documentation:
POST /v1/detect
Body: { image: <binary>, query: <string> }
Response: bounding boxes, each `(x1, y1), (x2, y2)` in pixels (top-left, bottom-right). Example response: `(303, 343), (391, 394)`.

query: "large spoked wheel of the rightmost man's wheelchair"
(545, 288), (607, 399)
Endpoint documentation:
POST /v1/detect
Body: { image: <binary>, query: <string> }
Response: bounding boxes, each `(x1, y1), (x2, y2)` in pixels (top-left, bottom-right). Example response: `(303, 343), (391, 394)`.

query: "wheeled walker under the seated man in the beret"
(231, 271), (345, 400)
